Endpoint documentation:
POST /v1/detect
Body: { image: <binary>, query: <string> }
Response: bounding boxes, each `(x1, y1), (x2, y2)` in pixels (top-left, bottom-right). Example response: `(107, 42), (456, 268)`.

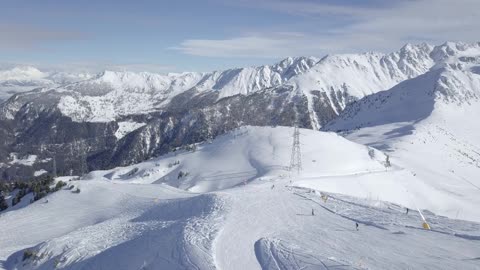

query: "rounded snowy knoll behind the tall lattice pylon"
(85, 127), (386, 192)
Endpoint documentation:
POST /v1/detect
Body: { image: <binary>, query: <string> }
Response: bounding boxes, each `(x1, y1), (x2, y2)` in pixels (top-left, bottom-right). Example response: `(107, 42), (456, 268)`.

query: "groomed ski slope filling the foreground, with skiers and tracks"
(2, 180), (480, 269)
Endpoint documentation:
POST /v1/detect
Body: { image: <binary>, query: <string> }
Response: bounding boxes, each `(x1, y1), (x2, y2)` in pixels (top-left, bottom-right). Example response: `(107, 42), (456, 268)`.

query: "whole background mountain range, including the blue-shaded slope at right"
(0, 42), (480, 179)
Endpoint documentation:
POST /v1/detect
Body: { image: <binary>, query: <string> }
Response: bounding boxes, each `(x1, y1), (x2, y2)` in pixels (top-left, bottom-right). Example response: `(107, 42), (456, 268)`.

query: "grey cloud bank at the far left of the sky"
(0, 23), (87, 50)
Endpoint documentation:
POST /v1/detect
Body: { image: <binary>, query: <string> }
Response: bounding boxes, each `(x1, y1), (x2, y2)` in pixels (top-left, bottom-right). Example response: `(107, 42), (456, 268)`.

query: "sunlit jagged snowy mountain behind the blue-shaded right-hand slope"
(287, 44), (435, 129)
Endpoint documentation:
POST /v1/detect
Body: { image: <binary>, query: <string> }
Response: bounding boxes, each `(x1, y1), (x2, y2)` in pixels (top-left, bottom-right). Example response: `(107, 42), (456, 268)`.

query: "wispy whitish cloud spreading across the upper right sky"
(175, 0), (480, 57)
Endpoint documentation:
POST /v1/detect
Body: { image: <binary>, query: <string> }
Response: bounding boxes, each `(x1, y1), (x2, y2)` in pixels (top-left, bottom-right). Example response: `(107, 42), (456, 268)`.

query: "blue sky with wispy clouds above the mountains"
(0, 0), (480, 73)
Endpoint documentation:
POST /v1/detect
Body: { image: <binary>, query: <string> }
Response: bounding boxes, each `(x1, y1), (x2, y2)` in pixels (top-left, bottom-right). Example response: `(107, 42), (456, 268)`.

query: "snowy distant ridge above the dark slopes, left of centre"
(24, 57), (318, 122)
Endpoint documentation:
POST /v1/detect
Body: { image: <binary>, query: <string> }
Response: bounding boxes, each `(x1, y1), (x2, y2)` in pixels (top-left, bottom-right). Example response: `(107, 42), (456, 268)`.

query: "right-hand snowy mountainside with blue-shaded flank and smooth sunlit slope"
(325, 43), (480, 221)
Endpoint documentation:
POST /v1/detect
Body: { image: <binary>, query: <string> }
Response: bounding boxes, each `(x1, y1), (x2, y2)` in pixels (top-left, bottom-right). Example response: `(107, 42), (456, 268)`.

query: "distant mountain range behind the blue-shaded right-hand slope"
(0, 43), (480, 181)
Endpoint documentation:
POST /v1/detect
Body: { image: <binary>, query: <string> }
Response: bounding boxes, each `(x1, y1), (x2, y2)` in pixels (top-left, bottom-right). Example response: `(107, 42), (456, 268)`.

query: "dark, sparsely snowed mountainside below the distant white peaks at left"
(0, 88), (311, 179)
